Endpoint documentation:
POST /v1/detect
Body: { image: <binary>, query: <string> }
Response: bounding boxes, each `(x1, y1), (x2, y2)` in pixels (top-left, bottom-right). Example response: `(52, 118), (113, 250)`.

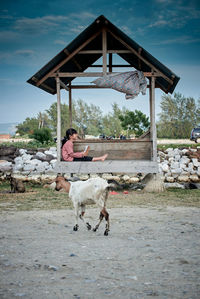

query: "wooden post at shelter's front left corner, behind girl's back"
(56, 77), (61, 162)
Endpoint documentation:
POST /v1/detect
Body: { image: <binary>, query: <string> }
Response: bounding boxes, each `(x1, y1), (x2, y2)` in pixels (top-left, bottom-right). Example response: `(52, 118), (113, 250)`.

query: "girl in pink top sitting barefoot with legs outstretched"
(62, 128), (108, 162)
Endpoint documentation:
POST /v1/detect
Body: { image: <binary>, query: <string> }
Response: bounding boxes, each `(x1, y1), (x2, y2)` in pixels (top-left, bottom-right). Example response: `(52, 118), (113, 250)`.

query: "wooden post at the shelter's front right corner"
(149, 77), (157, 162)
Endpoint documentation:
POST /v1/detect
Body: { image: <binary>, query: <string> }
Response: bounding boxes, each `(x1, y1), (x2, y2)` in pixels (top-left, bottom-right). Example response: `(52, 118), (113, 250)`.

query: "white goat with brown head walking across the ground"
(55, 176), (112, 236)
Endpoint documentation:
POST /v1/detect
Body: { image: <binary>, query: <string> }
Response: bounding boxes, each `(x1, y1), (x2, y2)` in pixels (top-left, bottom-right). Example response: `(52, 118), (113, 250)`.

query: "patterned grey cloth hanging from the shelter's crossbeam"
(92, 71), (147, 100)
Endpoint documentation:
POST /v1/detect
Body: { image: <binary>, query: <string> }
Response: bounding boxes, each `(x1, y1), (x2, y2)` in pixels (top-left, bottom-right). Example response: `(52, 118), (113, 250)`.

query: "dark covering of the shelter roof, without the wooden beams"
(27, 15), (180, 94)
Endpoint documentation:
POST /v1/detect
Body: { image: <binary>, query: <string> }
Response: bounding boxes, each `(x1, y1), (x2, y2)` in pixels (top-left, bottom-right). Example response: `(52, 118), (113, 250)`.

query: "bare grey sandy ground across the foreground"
(0, 207), (200, 299)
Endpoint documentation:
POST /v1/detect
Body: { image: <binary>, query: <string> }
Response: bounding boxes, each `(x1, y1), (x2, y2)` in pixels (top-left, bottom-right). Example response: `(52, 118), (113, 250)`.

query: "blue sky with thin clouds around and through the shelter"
(0, 0), (200, 123)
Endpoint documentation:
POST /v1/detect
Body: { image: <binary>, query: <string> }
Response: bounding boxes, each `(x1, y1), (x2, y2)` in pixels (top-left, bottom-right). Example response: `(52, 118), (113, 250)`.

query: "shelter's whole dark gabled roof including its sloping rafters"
(27, 15), (180, 94)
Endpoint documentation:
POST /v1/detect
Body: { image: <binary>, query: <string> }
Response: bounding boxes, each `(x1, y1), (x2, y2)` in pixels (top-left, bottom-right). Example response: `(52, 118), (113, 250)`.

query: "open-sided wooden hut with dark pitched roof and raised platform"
(27, 16), (180, 173)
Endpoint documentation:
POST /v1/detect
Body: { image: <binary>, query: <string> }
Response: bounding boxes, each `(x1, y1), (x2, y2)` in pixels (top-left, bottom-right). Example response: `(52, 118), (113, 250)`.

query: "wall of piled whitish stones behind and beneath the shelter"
(0, 146), (200, 184)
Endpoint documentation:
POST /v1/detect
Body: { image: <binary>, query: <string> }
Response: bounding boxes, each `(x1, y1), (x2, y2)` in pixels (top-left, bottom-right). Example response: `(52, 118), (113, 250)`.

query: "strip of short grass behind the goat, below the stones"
(0, 182), (200, 212)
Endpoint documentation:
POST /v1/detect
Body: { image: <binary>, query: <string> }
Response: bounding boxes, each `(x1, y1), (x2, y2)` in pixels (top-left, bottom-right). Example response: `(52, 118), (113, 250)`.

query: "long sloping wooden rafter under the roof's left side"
(36, 31), (101, 86)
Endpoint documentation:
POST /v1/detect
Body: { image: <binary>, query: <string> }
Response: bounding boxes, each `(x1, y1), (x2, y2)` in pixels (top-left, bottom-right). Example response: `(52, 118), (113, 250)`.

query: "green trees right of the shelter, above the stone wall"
(157, 93), (200, 138)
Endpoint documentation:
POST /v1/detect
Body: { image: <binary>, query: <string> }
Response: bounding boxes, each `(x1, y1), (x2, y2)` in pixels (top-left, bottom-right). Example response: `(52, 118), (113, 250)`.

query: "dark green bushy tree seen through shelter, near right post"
(119, 110), (150, 137)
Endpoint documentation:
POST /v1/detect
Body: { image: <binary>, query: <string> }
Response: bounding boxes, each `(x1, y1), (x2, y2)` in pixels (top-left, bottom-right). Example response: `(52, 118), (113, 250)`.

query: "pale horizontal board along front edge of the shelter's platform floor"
(54, 160), (158, 174)
